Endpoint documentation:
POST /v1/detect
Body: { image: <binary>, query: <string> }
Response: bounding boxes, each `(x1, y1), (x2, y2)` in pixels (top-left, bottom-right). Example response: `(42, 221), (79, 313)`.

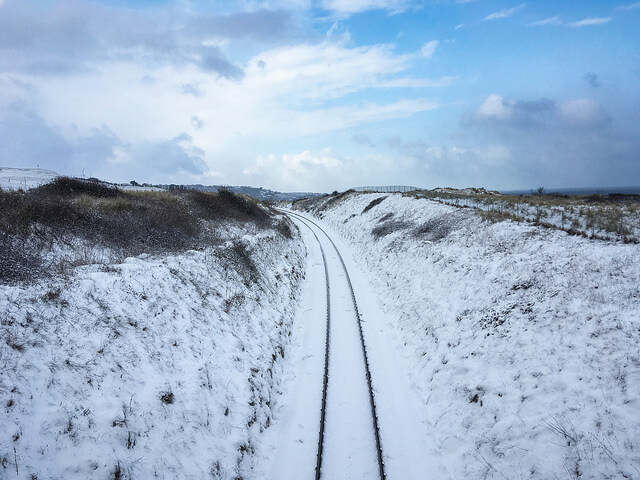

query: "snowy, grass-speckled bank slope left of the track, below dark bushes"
(0, 230), (305, 480)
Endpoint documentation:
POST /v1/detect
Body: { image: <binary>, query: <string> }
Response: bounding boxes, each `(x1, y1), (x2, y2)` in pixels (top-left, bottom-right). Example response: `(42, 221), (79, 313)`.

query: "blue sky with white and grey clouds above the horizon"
(0, 0), (640, 192)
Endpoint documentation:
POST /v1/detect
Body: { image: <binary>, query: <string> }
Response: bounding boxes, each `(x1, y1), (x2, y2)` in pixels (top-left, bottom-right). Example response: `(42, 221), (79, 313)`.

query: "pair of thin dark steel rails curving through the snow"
(283, 211), (387, 480)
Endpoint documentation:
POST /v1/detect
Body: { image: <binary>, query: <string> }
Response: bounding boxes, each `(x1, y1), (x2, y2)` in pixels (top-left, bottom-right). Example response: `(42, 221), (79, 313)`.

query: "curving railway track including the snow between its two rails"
(284, 211), (386, 480)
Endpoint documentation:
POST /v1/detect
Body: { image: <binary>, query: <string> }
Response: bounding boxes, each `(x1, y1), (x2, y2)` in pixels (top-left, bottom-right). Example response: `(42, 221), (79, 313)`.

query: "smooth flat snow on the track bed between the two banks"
(259, 213), (430, 479)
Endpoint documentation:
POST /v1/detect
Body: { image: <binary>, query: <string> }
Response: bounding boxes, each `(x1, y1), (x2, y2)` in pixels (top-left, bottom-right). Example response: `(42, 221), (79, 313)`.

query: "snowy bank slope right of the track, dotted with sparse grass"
(296, 194), (640, 479)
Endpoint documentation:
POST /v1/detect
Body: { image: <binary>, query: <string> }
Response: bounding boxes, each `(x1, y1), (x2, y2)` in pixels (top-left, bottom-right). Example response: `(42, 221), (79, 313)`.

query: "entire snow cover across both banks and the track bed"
(0, 183), (640, 480)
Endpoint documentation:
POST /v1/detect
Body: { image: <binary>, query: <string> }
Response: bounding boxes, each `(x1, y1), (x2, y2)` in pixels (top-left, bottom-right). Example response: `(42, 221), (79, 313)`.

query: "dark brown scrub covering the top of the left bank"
(0, 177), (293, 282)
